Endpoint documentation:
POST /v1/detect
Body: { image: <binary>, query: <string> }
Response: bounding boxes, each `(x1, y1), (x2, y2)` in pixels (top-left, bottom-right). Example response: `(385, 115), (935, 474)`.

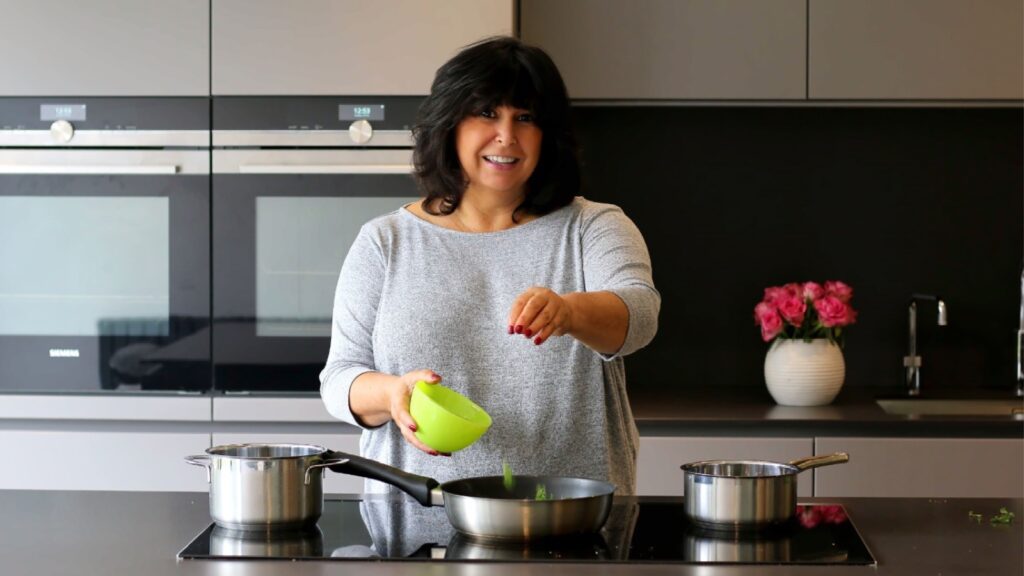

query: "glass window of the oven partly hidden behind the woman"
(256, 197), (417, 337)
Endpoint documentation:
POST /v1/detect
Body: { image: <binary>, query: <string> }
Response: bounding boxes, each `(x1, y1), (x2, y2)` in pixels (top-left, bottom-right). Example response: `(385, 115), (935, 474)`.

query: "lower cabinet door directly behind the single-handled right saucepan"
(637, 437), (815, 496)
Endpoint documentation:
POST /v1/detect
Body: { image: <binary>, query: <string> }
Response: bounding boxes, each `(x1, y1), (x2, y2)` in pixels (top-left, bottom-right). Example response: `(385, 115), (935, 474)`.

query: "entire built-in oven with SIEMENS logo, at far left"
(0, 96), (210, 393)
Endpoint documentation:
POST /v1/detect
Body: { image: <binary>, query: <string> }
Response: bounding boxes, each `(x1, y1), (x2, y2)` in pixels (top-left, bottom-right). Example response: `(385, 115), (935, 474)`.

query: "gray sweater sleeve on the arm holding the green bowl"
(319, 227), (385, 428)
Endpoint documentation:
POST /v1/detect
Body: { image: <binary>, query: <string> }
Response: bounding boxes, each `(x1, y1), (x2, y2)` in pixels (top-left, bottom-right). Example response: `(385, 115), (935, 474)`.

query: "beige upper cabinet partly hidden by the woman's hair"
(213, 0), (513, 95)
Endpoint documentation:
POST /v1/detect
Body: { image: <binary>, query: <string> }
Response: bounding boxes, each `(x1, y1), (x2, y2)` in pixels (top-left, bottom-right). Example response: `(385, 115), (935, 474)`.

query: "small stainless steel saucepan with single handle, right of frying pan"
(680, 452), (850, 531)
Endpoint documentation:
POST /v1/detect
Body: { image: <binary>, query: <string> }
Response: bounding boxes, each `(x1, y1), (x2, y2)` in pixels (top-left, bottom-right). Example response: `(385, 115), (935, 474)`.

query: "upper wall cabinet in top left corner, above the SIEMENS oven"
(0, 0), (210, 96)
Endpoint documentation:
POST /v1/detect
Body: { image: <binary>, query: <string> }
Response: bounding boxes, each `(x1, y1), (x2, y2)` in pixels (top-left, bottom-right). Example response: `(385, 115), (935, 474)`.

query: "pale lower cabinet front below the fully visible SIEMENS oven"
(0, 429), (210, 492)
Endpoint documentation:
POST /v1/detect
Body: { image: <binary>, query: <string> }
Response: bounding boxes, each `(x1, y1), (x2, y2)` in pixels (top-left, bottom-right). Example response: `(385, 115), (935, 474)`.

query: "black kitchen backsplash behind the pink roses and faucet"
(575, 106), (1024, 394)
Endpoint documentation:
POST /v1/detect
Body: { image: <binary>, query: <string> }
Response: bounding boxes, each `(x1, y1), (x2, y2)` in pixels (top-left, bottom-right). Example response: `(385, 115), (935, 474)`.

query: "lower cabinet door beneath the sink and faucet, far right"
(814, 438), (1024, 498)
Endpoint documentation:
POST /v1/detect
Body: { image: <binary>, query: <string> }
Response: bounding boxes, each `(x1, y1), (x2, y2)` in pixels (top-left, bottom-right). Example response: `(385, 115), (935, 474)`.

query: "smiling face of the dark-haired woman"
(455, 106), (542, 197)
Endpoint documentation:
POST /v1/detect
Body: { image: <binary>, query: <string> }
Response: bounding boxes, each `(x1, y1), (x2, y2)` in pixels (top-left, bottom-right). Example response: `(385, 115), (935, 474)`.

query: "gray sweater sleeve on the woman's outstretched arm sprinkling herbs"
(582, 203), (662, 360)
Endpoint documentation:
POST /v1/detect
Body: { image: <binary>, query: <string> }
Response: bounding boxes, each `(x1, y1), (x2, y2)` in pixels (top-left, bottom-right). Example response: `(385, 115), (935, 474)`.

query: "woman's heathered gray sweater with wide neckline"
(321, 198), (660, 494)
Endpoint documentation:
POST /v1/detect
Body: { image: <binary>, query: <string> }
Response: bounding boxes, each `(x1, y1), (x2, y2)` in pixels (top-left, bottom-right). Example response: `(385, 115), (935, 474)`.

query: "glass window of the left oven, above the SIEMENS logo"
(0, 196), (171, 336)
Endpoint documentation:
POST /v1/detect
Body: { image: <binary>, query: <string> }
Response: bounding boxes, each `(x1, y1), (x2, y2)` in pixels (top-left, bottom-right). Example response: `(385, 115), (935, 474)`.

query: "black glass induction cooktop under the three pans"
(178, 498), (874, 565)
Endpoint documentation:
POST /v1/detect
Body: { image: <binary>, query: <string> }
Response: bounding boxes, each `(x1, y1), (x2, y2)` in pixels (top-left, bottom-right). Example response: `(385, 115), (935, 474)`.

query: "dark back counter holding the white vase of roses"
(629, 386), (1024, 439)
